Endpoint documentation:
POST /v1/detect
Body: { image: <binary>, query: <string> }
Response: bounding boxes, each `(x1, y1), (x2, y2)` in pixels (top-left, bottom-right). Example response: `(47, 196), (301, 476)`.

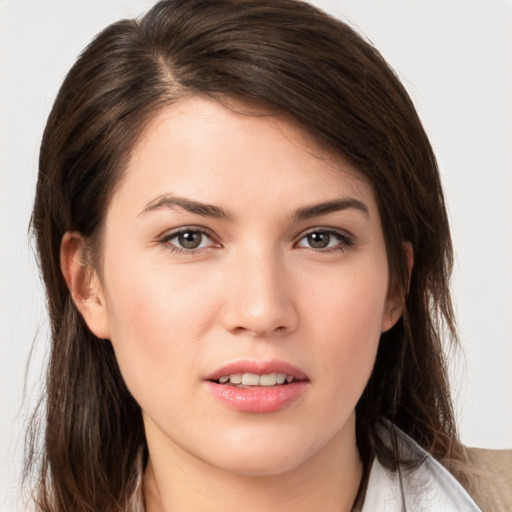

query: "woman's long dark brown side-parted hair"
(26, 0), (464, 512)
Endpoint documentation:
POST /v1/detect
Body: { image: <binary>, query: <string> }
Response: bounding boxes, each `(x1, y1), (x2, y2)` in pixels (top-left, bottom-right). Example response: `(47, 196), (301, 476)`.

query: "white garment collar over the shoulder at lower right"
(362, 426), (481, 512)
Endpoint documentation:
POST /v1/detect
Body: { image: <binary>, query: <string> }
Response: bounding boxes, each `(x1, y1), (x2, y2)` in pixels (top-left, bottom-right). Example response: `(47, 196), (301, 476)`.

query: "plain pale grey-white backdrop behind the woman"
(0, 0), (512, 512)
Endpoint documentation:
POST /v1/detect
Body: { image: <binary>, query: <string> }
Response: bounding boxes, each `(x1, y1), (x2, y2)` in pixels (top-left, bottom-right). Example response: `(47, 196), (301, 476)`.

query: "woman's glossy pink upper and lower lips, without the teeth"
(205, 360), (309, 414)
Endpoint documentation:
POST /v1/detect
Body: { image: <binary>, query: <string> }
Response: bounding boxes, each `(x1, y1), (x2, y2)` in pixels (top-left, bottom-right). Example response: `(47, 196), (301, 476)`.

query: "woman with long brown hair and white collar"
(27, 0), (484, 512)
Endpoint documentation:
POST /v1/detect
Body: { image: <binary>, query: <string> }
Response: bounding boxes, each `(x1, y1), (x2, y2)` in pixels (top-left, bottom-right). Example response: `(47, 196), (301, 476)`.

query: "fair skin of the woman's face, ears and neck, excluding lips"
(61, 97), (408, 512)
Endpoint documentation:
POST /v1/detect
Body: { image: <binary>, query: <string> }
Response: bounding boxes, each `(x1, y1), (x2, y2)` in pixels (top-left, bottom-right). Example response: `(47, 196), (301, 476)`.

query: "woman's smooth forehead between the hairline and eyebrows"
(113, 96), (373, 218)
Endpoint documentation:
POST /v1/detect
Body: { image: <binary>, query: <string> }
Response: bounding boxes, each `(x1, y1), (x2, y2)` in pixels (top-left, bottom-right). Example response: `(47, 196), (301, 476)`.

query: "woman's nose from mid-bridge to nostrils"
(221, 247), (298, 337)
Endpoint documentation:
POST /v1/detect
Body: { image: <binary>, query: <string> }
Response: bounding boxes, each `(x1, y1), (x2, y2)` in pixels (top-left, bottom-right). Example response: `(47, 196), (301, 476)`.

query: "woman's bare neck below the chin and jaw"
(144, 416), (363, 512)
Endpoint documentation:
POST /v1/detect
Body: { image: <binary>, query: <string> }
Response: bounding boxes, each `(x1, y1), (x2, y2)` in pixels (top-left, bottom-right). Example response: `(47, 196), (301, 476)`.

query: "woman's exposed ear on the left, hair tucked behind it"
(60, 231), (110, 339)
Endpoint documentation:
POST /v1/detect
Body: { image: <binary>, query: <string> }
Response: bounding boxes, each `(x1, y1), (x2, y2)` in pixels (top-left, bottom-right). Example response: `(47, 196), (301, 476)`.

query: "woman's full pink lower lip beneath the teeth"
(206, 381), (308, 414)
